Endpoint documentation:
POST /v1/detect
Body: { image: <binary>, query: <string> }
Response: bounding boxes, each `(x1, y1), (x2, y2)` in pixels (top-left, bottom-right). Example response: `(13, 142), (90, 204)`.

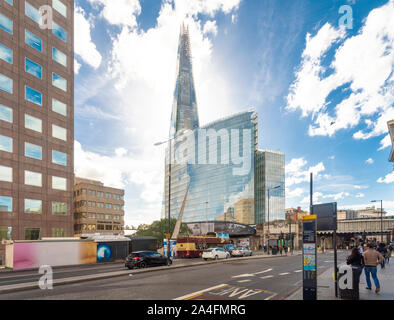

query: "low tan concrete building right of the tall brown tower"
(74, 177), (124, 236)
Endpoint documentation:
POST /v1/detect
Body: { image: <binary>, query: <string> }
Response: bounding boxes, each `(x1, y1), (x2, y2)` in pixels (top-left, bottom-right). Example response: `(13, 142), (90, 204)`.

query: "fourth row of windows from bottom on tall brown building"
(0, 135), (67, 166)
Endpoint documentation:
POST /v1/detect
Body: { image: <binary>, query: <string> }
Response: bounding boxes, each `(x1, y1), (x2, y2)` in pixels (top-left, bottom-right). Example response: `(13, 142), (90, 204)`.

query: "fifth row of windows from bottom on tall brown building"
(0, 105), (67, 139)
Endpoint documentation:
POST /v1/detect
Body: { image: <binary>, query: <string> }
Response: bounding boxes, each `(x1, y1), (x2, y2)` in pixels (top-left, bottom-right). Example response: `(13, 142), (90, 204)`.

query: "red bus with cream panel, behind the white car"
(176, 234), (230, 258)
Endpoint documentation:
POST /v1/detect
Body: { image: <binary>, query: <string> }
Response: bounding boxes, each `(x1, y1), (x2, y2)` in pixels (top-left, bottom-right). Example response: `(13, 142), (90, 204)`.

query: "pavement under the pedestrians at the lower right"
(286, 260), (394, 300)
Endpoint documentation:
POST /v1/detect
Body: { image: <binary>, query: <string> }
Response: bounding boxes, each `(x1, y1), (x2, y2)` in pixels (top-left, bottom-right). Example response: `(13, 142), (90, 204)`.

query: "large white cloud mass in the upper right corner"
(286, 0), (394, 144)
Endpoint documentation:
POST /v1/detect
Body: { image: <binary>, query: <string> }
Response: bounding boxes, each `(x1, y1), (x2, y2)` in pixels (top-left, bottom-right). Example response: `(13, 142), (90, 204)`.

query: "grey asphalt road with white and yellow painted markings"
(0, 252), (348, 300)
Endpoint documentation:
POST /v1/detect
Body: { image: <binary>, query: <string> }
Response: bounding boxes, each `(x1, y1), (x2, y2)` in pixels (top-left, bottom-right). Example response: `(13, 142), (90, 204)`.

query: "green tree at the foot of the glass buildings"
(135, 219), (192, 246)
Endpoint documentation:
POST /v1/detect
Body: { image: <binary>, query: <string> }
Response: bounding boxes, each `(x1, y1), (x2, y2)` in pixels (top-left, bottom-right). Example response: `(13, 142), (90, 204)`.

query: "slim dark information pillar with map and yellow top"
(302, 215), (317, 300)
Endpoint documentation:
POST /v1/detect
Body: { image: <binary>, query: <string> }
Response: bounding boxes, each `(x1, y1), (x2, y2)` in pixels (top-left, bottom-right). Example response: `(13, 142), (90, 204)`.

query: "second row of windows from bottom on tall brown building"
(0, 196), (67, 216)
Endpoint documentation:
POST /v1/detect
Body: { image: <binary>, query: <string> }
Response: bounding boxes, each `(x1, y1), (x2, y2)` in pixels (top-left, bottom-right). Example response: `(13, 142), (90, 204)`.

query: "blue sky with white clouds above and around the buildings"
(75, 0), (394, 226)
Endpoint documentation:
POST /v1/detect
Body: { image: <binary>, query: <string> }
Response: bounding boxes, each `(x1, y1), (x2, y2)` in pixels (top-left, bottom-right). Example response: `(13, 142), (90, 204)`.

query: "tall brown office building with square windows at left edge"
(0, 0), (74, 262)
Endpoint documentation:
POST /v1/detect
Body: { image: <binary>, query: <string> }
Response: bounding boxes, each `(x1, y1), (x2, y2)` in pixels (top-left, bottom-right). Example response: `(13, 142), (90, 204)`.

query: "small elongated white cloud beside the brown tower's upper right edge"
(74, 6), (102, 70)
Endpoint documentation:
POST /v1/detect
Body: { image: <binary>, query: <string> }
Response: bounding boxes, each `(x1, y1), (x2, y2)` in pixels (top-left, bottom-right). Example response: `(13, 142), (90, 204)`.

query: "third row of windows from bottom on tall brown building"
(0, 166), (67, 191)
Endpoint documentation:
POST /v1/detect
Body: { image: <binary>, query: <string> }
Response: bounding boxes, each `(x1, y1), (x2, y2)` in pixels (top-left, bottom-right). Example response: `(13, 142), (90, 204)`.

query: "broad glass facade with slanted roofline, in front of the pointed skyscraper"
(165, 111), (257, 224)
